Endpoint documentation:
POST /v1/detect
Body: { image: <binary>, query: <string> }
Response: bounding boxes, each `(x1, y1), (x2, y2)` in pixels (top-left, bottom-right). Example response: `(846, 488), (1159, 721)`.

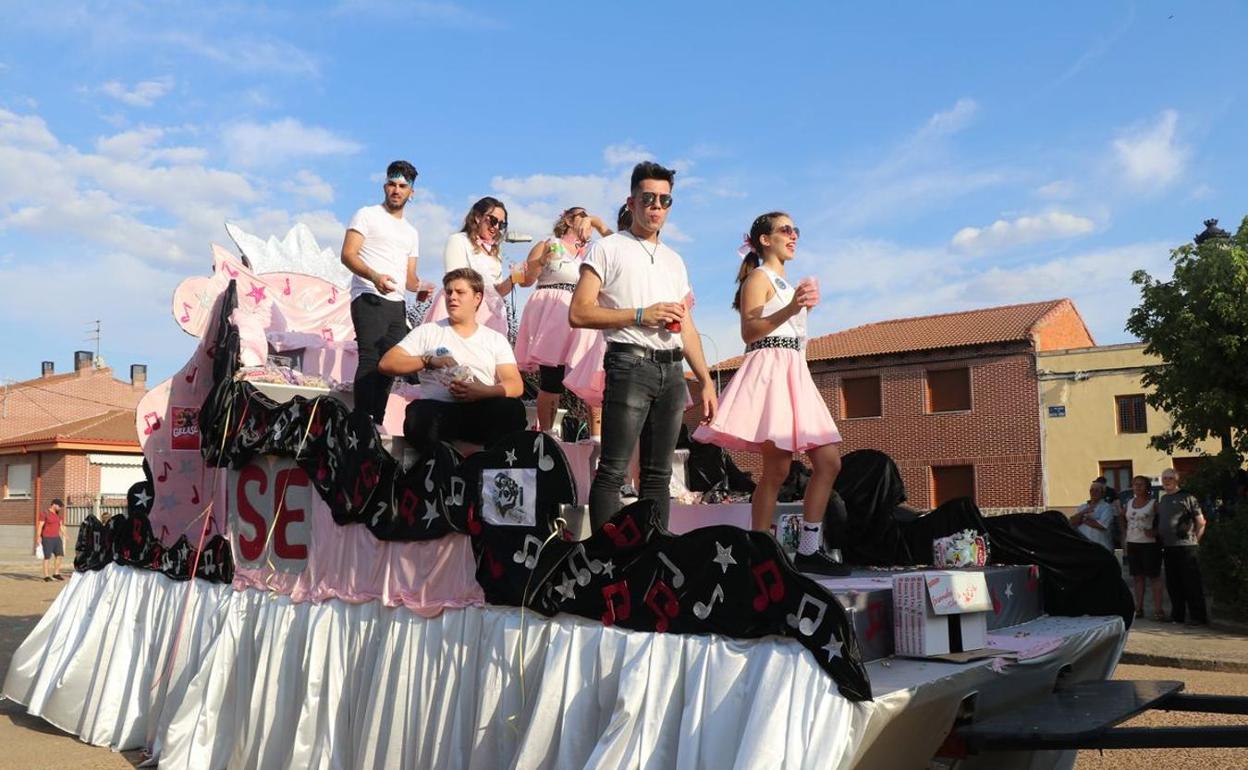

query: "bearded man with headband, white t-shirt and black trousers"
(342, 161), (421, 424)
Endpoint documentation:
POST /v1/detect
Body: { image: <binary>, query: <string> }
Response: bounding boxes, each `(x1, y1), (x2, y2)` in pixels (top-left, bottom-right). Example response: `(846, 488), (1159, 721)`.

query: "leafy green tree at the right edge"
(1127, 217), (1248, 469)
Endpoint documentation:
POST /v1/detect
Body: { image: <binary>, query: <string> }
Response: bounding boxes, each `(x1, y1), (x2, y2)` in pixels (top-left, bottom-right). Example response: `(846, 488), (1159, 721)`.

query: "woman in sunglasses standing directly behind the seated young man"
(424, 196), (515, 336)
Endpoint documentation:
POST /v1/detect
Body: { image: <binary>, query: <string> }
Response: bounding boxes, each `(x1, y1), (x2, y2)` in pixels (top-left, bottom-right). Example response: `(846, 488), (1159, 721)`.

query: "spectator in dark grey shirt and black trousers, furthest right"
(1157, 468), (1209, 625)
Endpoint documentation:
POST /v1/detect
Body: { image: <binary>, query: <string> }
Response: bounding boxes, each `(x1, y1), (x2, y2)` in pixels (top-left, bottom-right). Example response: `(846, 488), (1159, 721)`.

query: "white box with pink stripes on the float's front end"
(892, 570), (992, 656)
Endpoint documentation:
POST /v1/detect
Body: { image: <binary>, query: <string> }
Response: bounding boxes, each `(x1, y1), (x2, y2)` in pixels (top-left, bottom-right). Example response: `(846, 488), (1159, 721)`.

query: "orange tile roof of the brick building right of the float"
(716, 300), (1082, 369)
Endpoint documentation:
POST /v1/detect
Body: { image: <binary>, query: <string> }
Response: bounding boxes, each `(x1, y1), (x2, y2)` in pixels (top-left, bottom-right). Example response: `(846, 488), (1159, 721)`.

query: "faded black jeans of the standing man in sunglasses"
(589, 352), (689, 529)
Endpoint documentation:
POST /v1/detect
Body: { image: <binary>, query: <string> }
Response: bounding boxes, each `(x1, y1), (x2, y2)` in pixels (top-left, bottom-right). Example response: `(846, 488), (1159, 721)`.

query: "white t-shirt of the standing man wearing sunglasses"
(580, 232), (693, 351)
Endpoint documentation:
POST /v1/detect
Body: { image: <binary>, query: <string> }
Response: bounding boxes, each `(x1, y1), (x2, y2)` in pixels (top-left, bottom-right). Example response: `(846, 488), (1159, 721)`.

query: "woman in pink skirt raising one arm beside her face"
(515, 206), (612, 431)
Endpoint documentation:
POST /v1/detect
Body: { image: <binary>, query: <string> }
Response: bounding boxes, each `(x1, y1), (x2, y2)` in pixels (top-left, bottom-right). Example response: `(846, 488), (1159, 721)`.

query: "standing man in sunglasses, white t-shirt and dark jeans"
(568, 161), (718, 528)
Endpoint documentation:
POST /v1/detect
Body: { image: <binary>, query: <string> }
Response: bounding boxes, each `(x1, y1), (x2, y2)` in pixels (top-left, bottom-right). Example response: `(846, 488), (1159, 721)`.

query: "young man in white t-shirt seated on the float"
(377, 267), (528, 452)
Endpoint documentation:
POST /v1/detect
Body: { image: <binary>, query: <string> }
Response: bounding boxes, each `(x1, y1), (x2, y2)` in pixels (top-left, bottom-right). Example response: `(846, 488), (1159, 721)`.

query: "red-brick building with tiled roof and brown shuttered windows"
(691, 300), (1094, 512)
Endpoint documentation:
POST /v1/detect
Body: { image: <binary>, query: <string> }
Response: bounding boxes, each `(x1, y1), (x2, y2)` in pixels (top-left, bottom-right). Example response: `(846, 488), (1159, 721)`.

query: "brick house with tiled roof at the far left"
(0, 351), (147, 548)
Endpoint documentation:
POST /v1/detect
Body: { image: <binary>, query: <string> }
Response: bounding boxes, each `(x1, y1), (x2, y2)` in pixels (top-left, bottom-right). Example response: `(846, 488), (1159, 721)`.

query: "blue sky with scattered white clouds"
(0, 0), (1248, 381)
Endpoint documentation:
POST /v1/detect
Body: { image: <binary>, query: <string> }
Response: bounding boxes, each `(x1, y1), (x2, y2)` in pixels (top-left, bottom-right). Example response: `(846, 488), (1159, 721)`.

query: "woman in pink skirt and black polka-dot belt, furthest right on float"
(694, 211), (847, 574)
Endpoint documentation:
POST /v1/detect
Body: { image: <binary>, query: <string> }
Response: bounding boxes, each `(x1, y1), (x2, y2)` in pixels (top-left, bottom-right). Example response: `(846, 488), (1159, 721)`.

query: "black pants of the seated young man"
(403, 396), (528, 454)
